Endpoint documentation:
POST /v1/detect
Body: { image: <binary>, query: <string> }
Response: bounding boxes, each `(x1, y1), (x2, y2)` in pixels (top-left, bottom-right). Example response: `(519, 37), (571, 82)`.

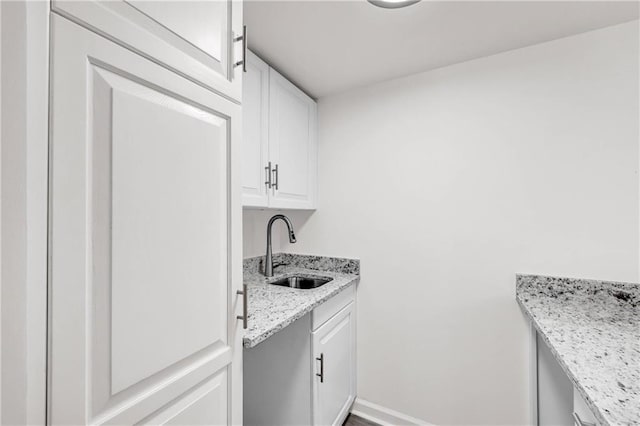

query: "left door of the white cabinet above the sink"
(242, 52), (271, 207)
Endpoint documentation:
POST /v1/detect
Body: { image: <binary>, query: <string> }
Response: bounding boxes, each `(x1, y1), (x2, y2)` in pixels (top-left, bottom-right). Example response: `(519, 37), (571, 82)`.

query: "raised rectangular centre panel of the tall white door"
(111, 76), (227, 393)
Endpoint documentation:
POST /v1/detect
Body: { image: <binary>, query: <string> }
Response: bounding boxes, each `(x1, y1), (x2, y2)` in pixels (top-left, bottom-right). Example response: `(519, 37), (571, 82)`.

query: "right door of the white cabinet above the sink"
(269, 69), (317, 209)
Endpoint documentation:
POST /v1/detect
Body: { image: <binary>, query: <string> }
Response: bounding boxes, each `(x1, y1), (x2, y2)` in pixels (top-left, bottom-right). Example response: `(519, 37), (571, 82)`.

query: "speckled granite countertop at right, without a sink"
(516, 275), (640, 425)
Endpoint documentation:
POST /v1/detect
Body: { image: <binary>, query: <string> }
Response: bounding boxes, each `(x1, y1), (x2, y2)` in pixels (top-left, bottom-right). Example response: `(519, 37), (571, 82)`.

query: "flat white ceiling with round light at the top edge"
(244, 0), (639, 98)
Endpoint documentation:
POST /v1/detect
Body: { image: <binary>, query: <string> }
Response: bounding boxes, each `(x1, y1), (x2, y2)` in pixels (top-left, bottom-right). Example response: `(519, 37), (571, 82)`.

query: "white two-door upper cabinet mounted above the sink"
(243, 50), (318, 210)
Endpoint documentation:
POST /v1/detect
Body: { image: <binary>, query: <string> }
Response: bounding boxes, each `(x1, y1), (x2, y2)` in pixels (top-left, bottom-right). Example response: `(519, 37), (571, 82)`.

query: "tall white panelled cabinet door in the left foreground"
(48, 15), (242, 425)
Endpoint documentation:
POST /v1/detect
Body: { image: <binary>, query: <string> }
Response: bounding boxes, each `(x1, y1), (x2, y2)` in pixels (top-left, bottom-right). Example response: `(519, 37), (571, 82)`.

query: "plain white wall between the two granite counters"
(245, 21), (640, 425)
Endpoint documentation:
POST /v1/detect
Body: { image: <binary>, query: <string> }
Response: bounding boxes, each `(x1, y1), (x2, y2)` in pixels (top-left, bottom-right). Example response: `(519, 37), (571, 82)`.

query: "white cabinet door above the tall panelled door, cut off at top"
(52, 0), (244, 101)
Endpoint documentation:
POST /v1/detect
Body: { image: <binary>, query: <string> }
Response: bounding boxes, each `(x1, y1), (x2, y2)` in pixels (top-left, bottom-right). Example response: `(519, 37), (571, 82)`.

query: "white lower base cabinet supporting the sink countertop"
(243, 286), (356, 426)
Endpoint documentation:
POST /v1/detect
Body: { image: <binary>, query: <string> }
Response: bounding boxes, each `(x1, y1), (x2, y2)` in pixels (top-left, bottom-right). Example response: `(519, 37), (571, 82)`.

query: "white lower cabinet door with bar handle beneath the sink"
(312, 303), (356, 426)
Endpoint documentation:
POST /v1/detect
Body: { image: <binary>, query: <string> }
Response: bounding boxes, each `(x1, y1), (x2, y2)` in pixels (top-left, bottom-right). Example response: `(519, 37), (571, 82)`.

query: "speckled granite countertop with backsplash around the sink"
(243, 253), (360, 348)
